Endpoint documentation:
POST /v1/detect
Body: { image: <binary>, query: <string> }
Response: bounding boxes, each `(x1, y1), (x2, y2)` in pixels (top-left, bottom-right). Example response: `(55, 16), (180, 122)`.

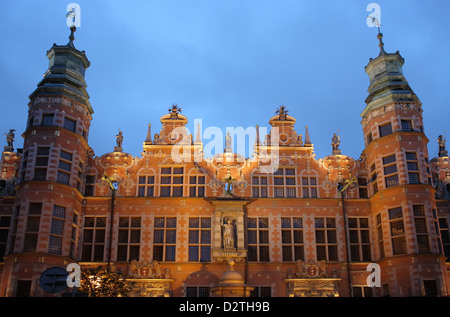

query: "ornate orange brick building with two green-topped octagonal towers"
(0, 29), (450, 297)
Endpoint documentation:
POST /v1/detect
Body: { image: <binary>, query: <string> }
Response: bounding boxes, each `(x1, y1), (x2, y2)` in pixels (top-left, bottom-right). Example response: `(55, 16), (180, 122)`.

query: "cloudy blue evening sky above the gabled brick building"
(0, 0), (450, 158)
